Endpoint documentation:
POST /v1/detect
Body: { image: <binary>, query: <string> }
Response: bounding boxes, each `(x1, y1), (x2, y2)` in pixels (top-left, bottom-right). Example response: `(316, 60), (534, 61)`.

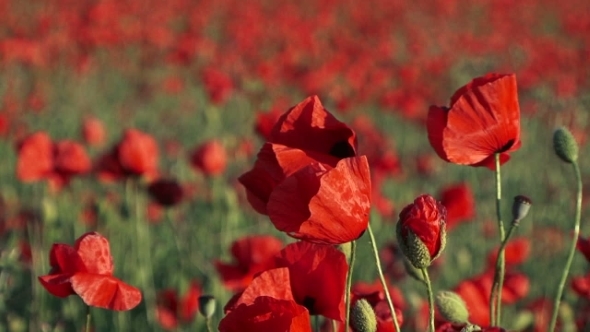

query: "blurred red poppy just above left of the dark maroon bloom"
(117, 129), (158, 176)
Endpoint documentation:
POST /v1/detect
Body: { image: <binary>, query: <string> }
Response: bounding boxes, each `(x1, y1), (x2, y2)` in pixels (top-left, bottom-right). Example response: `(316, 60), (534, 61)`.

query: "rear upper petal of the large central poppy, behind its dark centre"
(270, 96), (357, 159)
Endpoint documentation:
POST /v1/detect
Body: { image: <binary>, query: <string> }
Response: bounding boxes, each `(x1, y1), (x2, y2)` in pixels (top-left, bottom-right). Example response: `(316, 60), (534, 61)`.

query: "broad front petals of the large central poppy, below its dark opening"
(267, 156), (371, 244)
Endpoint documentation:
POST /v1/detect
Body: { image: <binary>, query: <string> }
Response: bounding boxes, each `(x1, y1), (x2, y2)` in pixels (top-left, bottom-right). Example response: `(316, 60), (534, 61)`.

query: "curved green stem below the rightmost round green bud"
(549, 162), (582, 332)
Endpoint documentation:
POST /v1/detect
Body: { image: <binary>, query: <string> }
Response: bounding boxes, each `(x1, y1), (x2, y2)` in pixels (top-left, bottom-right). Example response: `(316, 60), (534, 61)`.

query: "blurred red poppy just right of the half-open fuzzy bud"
(440, 183), (475, 230)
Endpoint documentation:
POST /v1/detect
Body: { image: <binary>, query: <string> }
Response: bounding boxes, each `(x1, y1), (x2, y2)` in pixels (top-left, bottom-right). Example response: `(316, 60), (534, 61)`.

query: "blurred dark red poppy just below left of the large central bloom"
(215, 235), (283, 291)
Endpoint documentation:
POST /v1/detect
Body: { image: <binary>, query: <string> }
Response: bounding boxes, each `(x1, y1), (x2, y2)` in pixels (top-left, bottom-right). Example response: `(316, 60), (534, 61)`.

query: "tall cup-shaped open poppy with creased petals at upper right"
(427, 74), (520, 169)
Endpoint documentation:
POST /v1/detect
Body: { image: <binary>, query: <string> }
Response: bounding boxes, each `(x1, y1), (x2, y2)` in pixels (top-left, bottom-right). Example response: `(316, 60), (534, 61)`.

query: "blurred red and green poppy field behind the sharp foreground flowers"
(0, 0), (590, 331)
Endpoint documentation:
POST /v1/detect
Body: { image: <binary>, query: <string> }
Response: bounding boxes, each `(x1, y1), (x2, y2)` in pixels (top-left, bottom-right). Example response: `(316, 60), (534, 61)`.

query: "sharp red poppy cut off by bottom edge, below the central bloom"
(219, 268), (311, 332)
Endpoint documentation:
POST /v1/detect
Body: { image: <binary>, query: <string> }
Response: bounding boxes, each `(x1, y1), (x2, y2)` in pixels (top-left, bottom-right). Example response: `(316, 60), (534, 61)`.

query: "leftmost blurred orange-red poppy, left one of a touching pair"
(16, 132), (53, 182)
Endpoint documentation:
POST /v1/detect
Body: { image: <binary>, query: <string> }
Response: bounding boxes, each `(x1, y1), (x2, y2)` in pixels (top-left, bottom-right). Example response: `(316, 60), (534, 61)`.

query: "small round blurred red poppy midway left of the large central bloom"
(190, 140), (227, 176)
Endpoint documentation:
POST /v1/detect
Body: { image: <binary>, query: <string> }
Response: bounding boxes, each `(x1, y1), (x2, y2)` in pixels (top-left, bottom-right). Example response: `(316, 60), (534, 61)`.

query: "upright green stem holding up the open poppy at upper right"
(490, 153), (505, 326)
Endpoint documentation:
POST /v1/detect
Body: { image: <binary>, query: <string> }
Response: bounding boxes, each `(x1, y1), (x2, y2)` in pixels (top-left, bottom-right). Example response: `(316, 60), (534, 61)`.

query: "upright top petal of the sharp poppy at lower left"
(74, 232), (114, 275)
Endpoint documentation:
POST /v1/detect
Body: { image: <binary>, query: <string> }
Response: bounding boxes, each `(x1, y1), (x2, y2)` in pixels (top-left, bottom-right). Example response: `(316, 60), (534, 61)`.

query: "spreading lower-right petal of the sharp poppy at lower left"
(70, 273), (141, 311)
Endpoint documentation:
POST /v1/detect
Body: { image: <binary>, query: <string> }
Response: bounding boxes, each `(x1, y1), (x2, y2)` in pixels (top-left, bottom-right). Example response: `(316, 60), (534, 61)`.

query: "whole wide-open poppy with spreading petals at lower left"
(38, 232), (141, 311)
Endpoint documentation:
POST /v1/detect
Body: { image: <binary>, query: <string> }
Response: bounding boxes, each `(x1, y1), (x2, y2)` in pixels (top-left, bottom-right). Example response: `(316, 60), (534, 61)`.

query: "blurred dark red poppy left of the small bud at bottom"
(156, 281), (201, 330)
